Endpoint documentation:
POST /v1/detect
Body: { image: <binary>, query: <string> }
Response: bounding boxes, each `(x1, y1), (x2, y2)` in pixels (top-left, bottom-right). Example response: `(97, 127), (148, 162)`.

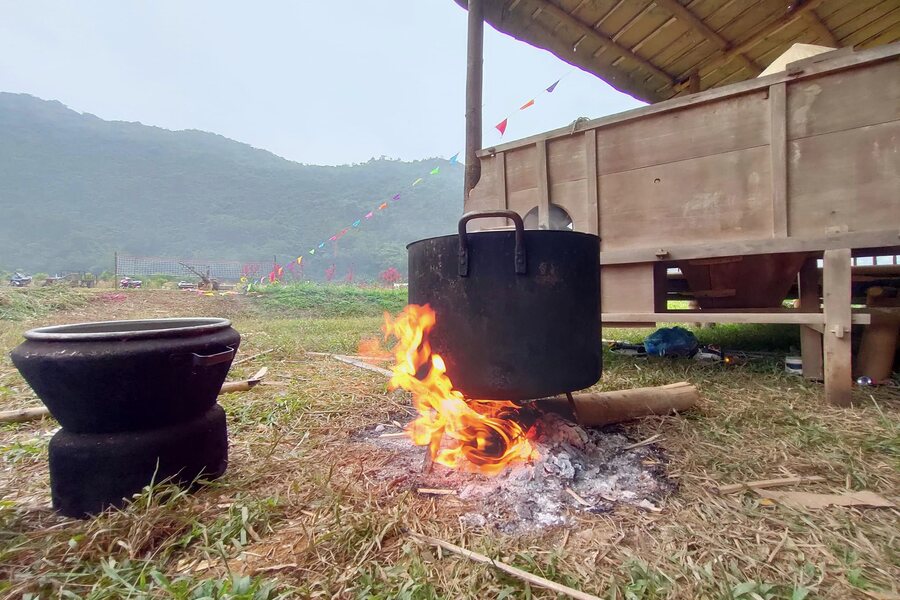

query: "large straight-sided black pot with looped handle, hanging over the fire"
(407, 211), (601, 400)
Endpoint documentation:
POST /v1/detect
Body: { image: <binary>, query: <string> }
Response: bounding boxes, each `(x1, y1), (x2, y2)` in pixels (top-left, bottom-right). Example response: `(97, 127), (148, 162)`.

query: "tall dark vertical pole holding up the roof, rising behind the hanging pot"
(463, 0), (484, 202)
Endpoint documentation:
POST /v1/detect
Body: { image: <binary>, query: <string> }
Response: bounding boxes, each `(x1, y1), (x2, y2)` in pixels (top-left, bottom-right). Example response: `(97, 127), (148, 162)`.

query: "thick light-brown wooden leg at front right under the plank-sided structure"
(822, 248), (853, 406)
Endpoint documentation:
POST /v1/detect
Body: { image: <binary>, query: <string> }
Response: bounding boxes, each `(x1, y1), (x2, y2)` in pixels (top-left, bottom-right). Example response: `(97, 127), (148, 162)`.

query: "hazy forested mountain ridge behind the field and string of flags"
(0, 93), (463, 279)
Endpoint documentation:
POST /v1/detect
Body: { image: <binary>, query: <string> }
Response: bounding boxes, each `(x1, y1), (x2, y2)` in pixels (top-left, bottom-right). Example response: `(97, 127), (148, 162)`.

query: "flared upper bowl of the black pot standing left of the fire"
(11, 318), (241, 433)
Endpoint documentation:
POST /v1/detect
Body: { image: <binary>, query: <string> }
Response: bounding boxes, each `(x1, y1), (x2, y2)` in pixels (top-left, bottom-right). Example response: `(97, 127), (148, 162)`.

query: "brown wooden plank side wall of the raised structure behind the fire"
(467, 49), (900, 264)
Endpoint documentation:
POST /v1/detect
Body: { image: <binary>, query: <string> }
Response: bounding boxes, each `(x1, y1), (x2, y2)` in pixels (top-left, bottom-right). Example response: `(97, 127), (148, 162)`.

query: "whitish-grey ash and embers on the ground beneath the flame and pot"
(360, 414), (675, 533)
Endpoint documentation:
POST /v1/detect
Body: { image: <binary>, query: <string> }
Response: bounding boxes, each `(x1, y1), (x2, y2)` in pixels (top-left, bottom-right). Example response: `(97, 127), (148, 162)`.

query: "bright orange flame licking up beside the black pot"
(383, 304), (537, 475)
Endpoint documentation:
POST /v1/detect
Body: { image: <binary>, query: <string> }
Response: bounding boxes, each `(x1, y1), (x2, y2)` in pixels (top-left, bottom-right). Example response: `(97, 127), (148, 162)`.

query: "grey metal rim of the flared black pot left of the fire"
(23, 317), (231, 342)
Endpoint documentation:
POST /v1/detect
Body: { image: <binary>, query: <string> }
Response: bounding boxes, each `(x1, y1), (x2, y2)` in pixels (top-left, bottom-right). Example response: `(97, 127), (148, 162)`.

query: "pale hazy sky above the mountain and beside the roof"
(0, 0), (639, 164)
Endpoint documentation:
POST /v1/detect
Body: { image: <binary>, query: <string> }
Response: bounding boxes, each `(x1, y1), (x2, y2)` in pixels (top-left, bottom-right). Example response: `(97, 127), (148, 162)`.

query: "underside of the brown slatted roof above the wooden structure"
(456, 0), (900, 102)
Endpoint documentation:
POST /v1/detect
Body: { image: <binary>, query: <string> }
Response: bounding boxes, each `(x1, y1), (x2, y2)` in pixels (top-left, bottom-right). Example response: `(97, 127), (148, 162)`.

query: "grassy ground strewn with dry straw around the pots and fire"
(0, 286), (900, 600)
